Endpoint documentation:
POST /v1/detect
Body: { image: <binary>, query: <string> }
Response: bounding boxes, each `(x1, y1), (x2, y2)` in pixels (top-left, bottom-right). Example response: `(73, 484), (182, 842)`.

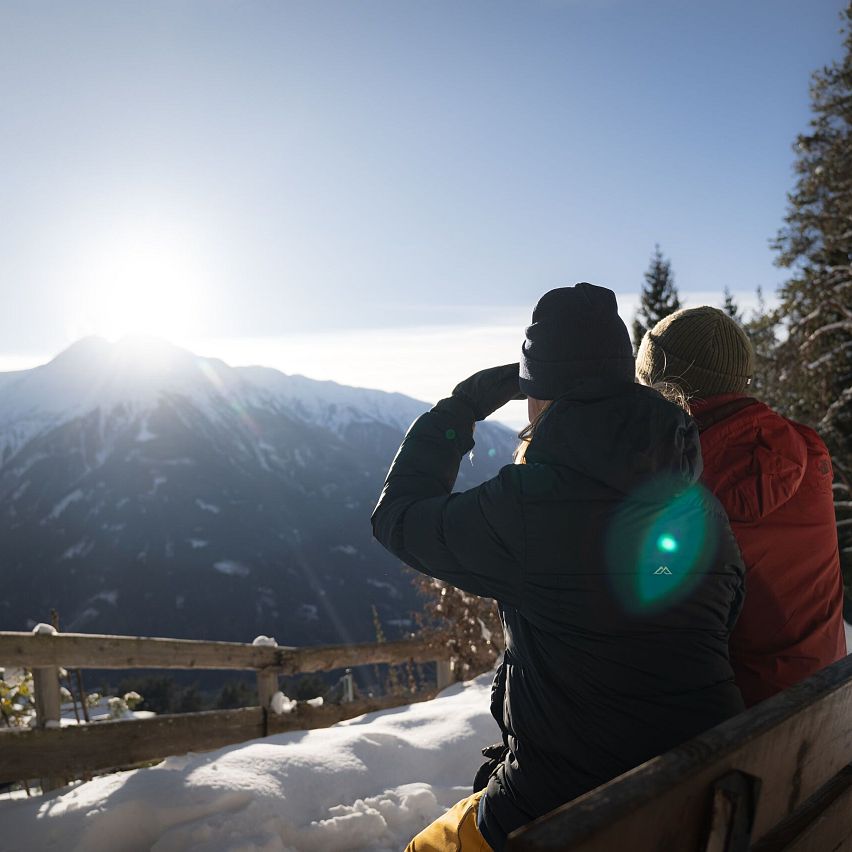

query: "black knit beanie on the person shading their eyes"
(519, 283), (634, 400)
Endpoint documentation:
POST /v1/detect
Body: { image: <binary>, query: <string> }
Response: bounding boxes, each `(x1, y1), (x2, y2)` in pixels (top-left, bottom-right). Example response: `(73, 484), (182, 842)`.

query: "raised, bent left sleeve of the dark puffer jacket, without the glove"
(372, 398), (523, 605)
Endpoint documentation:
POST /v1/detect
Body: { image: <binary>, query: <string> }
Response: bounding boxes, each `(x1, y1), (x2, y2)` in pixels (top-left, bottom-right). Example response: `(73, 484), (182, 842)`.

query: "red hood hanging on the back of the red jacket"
(694, 394), (809, 523)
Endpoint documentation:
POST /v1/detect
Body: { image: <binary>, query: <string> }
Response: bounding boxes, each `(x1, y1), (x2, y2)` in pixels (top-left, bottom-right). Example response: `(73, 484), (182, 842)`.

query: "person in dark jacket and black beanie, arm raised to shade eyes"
(372, 283), (744, 852)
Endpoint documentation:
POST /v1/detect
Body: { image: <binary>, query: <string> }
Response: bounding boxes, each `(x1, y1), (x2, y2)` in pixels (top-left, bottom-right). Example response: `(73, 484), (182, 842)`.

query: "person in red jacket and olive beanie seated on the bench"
(636, 307), (846, 707)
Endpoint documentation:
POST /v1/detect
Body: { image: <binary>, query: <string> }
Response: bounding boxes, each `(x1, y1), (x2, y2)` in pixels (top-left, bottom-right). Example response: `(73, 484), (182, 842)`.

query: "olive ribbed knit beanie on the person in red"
(636, 305), (754, 399)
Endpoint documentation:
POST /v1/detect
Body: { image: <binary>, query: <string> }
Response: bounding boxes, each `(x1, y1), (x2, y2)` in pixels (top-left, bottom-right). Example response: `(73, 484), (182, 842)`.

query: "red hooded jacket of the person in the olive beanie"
(692, 394), (846, 707)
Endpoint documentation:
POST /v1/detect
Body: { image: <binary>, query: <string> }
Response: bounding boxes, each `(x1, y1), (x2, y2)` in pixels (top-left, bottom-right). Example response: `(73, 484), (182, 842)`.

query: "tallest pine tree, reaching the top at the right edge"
(775, 2), (852, 582)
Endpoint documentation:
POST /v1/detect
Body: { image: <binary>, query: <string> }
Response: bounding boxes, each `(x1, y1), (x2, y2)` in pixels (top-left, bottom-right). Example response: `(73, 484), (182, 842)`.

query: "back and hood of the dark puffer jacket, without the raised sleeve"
(477, 383), (743, 834)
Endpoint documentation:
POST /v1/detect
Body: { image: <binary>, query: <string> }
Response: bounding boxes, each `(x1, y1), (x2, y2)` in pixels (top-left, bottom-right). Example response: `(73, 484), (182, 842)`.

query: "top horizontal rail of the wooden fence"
(0, 632), (449, 675)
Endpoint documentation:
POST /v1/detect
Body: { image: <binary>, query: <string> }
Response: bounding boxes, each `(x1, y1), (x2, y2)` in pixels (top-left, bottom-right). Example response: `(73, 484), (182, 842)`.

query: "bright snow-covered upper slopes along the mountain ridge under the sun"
(0, 337), (426, 458)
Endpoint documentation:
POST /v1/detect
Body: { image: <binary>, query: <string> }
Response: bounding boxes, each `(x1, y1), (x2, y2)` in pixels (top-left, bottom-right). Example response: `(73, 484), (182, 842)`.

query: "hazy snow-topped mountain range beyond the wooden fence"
(0, 338), (516, 645)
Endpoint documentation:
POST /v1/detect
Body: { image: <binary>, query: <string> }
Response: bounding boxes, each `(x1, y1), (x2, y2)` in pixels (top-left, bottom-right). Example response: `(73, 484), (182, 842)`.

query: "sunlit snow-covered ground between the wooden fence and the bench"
(0, 674), (499, 852)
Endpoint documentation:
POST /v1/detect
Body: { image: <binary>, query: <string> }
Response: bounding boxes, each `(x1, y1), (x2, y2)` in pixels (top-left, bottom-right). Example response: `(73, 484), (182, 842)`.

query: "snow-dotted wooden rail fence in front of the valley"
(0, 632), (451, 790)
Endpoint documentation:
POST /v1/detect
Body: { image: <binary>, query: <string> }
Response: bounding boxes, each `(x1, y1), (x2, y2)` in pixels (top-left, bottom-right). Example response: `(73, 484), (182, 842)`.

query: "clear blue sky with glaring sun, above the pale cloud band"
(0, 0), (844, 412)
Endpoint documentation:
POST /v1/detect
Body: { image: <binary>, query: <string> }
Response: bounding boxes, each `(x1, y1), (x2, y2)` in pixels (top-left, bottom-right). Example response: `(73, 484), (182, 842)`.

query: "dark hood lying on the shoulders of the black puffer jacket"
(525, 379), (703, 494)
